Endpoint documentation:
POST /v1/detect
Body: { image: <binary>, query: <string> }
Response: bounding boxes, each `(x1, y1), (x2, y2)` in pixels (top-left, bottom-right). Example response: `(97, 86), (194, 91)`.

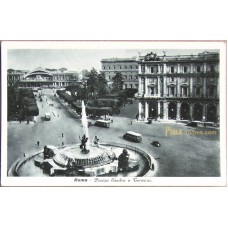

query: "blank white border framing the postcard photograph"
(1, 41), (227, 186)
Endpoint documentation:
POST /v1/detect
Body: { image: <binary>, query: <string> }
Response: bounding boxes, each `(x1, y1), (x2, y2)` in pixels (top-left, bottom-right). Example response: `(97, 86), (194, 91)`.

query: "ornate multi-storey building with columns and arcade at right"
(138, 52), (219, 122)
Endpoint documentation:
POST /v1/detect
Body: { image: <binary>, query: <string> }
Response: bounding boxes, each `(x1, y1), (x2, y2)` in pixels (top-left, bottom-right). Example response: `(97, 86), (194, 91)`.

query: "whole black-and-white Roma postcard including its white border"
(1, 41), (227, 187)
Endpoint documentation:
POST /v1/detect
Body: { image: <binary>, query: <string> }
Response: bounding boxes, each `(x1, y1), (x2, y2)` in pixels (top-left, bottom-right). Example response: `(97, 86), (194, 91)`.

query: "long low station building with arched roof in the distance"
(7, 67), (78, 88)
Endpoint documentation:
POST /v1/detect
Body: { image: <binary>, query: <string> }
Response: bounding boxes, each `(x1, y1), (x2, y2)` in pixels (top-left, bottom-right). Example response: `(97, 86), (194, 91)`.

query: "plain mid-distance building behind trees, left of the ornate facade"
(101, 58), (138, 89)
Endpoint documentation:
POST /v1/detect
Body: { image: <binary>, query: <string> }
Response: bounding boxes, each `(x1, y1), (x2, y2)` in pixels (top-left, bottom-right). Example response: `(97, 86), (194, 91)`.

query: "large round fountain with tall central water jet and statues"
(8, 101), (155, 176)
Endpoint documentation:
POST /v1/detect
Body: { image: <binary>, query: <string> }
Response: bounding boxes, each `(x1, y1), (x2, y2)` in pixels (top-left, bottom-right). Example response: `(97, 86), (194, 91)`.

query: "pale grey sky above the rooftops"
(7, 49), (215, 72)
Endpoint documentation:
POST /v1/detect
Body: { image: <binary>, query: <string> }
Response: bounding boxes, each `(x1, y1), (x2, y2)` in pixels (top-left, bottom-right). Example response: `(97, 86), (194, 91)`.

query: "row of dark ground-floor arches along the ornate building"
(148, 102), (217, 122)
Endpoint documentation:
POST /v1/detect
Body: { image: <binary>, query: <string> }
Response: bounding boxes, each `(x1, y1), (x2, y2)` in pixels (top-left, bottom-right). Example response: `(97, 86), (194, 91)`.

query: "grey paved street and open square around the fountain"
(8, 89), (220, 177)
